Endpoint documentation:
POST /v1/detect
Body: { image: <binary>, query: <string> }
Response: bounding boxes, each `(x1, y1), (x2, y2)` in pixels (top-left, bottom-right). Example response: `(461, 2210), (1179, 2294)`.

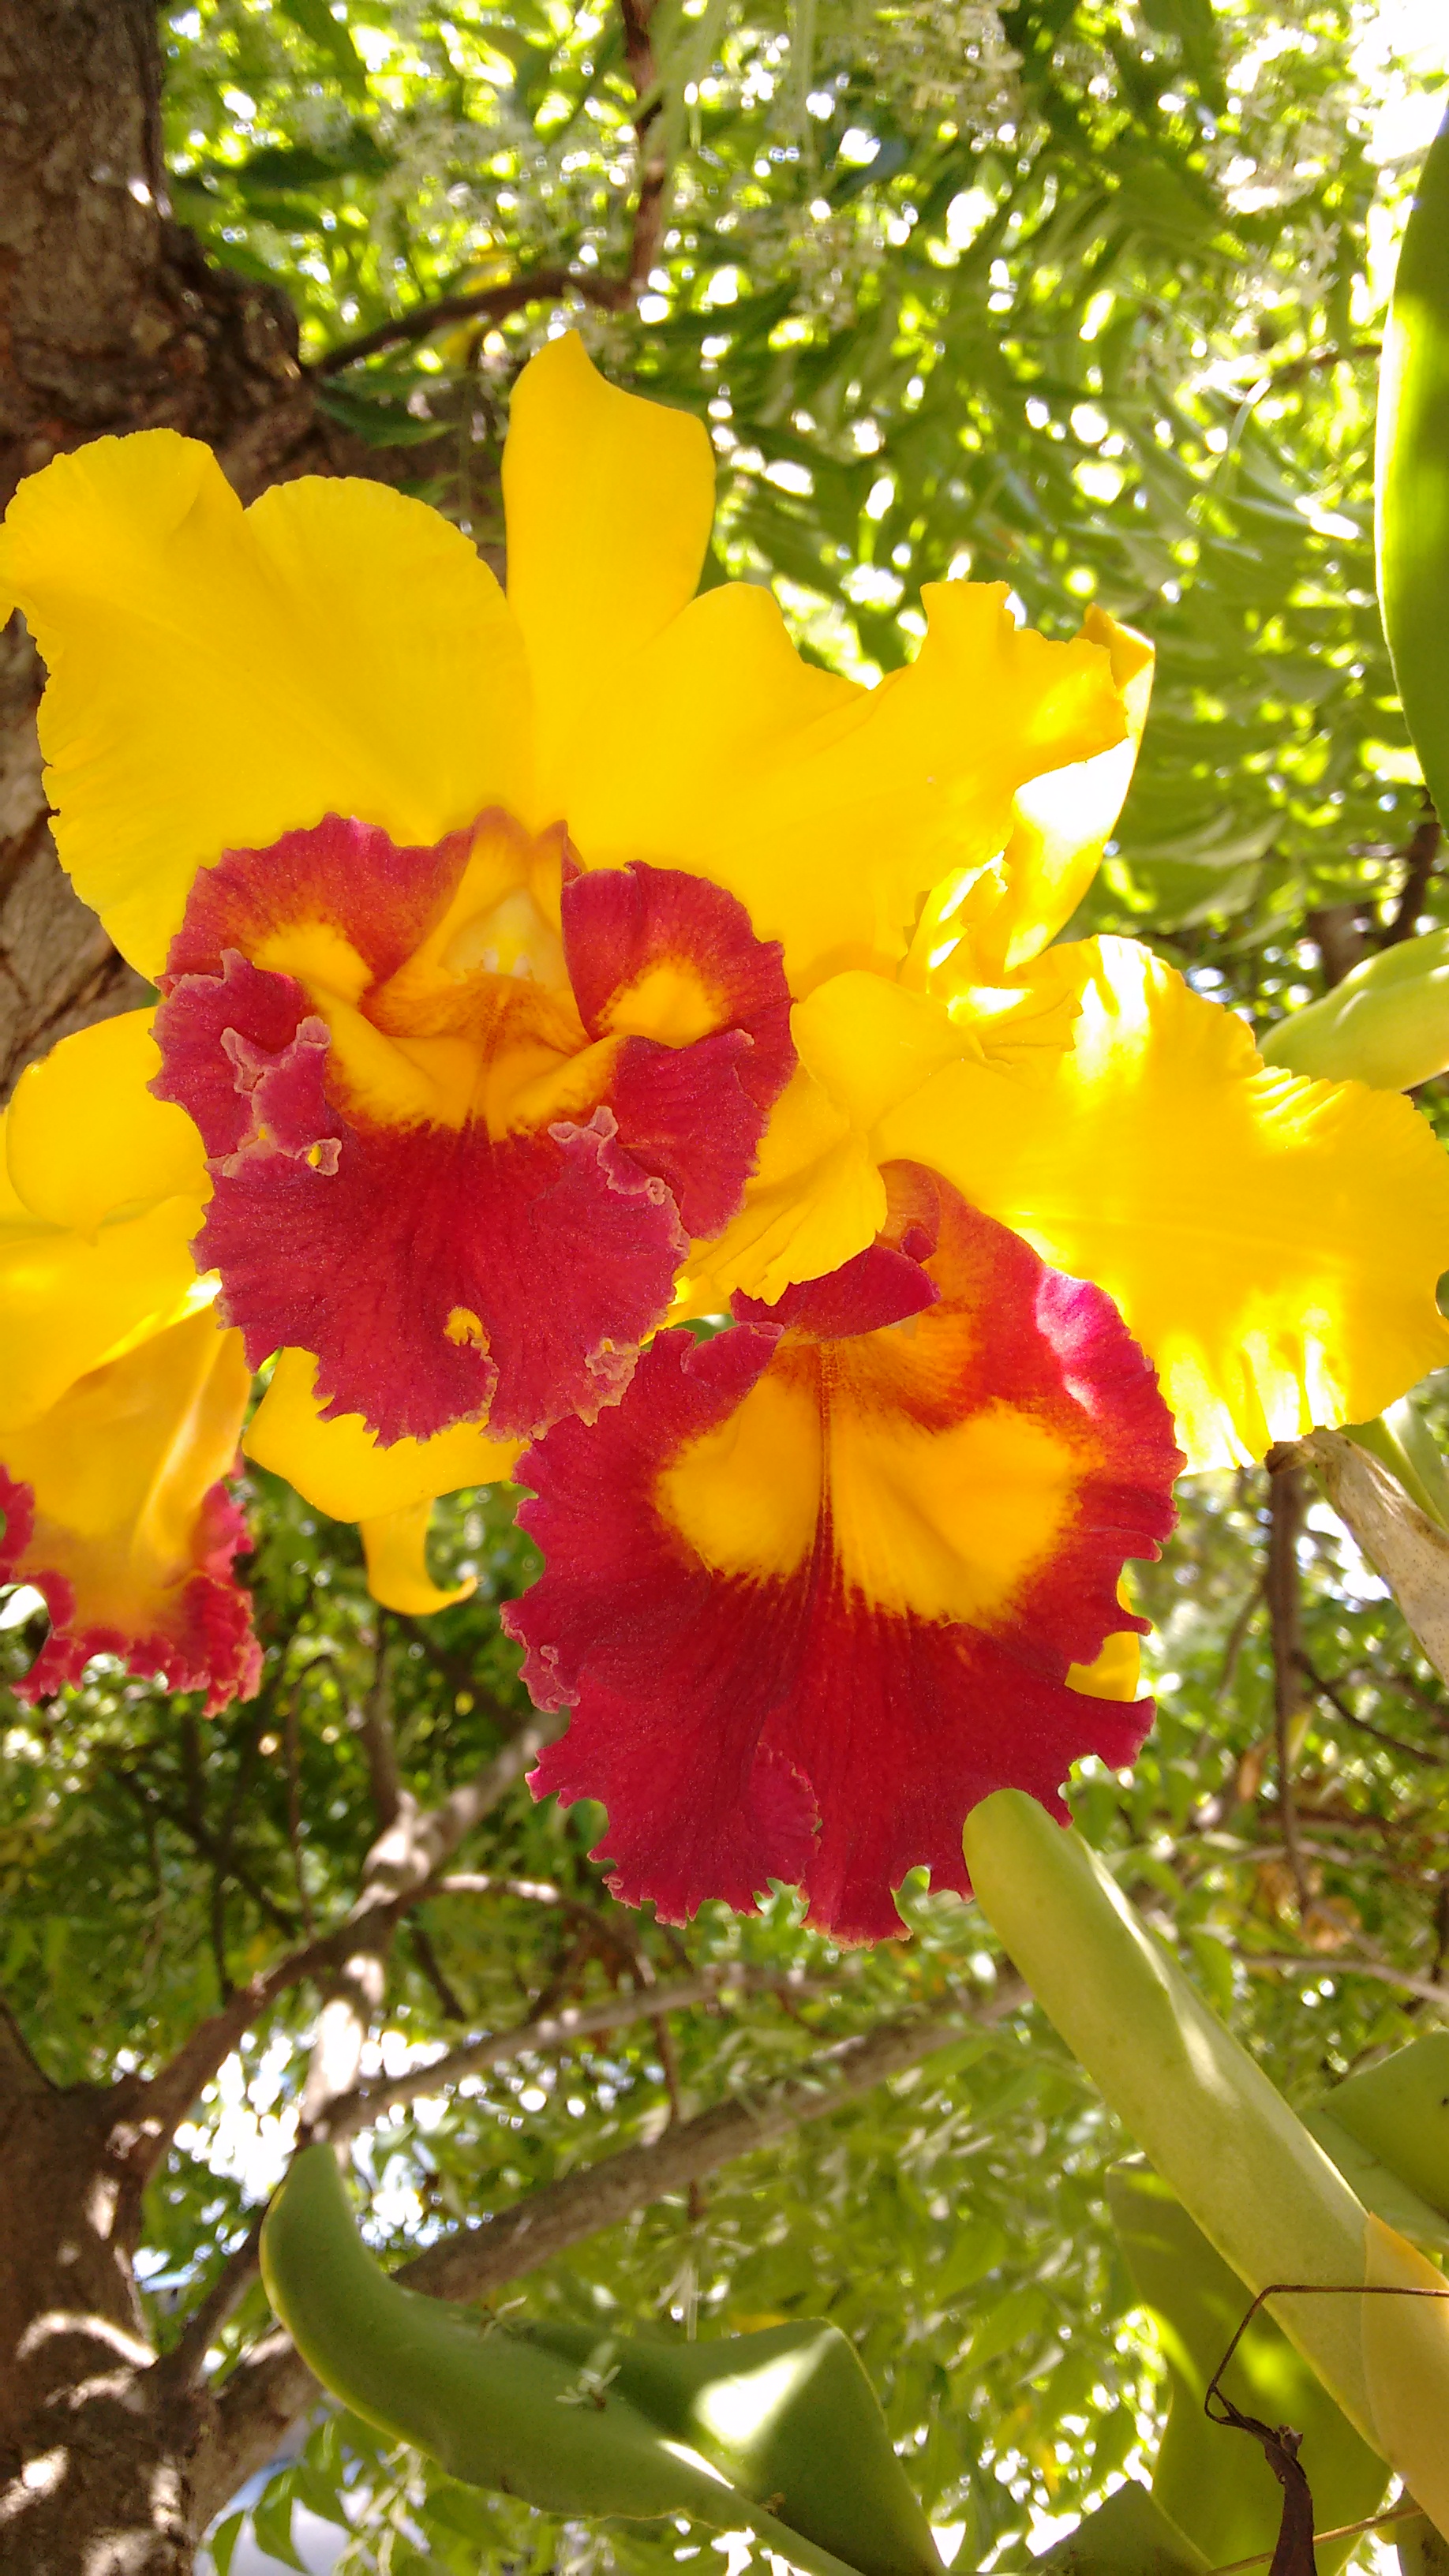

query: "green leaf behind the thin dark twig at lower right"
(1106, 2159), (1390, 2576)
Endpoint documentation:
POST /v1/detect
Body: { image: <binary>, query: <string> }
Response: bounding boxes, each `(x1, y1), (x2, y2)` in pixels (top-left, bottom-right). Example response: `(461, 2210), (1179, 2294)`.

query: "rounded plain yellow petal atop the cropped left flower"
(6, 1009), (212, 1234)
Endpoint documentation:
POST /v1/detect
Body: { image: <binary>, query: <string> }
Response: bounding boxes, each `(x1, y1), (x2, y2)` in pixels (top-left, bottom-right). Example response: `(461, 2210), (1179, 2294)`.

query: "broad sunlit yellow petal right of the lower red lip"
(874, 940), (1449, 1466)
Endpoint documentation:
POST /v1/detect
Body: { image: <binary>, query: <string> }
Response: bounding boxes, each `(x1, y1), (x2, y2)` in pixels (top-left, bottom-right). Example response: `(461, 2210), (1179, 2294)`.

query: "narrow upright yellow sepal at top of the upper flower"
(500, 332), (714, 822)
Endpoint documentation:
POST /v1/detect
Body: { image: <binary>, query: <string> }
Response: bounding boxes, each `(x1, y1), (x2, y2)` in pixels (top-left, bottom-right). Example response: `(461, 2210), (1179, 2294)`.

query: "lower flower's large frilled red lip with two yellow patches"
(505, 1164), (1181, 1940)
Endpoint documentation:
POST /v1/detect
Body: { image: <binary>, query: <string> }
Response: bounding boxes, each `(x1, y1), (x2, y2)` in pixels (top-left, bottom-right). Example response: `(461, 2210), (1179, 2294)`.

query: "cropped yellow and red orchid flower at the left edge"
(0, 1013), (260, 1713)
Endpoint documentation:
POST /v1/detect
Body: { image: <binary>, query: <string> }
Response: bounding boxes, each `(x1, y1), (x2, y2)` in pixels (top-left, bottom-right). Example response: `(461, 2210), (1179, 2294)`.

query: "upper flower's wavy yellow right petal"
(567, 582), (1127, 994)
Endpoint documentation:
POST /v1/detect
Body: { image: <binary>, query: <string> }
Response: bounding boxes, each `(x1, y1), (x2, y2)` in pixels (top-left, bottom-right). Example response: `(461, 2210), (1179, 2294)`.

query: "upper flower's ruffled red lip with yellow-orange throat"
(157, 814), (794, 1440)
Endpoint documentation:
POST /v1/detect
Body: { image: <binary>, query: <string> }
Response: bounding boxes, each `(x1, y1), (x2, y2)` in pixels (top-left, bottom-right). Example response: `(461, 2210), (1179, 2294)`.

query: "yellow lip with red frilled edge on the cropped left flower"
(0, 1311), (260, 1716)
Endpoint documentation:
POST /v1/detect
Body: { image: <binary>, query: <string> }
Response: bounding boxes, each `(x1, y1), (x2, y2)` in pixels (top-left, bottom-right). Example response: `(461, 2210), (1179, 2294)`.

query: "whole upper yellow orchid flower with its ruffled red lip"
(0, 338), (1127, 1517)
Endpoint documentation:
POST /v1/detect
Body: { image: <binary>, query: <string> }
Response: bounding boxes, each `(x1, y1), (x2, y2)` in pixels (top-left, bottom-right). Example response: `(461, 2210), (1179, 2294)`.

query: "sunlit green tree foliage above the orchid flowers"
(170, 0), (1418, 1015)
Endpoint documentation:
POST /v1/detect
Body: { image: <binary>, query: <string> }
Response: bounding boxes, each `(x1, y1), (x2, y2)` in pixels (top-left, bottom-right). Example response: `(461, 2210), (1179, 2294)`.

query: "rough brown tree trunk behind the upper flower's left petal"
(0, 0), (451, 1100)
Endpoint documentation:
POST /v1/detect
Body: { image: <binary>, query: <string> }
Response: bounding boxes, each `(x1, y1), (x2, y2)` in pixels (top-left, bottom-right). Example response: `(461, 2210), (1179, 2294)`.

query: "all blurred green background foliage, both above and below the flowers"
(0, 0), (1449, 2576)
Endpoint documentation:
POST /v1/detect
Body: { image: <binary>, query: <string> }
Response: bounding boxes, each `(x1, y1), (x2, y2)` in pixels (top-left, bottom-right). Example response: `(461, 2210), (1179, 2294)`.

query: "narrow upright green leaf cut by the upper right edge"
(1377, 105), (1449, 814)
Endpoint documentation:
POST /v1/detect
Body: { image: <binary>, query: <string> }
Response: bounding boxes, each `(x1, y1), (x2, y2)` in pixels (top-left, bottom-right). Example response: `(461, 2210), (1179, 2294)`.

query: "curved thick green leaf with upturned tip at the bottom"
(263, 2146), (941, 2576)
